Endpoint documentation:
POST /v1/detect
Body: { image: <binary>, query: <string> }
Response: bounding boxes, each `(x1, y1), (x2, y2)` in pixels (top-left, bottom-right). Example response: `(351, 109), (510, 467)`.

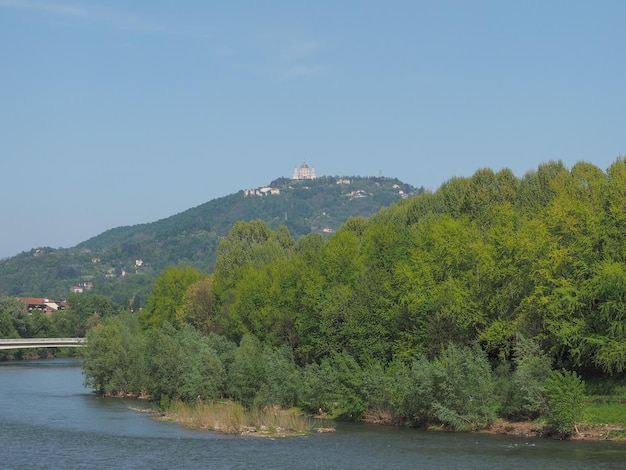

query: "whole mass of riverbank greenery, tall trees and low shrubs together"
(79, 158), (626, 434)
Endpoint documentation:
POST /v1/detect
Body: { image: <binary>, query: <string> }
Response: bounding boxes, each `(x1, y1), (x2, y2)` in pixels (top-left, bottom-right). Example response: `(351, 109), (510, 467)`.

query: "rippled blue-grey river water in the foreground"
(0, 359), (626, 470)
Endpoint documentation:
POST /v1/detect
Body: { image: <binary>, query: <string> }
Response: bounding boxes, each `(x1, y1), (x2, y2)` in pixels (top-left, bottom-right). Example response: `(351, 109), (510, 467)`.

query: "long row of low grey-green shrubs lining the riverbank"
(84, 316), (620, 434)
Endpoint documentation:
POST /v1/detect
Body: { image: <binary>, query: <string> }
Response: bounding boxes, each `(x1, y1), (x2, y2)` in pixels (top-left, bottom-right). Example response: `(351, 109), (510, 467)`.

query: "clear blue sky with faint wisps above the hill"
(0, 0), (626, 257)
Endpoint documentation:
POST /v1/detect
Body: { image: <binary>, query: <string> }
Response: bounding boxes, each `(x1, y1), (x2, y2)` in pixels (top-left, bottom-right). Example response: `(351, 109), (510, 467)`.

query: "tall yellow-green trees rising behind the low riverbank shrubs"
(205, 158), (626, 373)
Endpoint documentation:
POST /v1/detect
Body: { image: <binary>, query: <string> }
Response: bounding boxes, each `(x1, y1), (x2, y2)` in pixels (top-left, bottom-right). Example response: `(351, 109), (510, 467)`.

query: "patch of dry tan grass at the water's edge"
(158, 401), (334, 437)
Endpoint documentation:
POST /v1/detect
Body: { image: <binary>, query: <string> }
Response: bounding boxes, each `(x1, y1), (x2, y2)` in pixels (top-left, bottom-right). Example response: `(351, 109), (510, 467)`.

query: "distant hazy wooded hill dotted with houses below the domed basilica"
(0, 177), (421, 307)
